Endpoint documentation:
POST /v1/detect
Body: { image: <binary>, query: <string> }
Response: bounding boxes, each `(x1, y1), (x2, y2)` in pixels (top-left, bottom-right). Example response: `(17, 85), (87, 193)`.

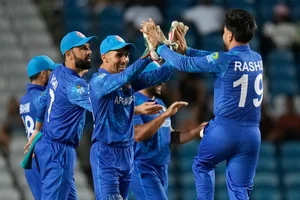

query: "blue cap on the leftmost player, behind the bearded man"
(27, 55), (55, 77)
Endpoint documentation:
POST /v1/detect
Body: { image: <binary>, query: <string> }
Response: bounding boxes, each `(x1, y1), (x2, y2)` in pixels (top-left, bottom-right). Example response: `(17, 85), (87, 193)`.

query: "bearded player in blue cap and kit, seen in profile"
(28, 31), (95, 200)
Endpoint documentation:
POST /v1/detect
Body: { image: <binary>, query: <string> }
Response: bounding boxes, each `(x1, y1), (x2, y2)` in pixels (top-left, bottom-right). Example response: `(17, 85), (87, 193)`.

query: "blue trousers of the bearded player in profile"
(34, 136), (78, 200)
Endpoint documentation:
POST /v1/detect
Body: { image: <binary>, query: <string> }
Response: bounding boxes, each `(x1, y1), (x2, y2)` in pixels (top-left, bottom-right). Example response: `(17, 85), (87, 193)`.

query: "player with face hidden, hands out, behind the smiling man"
(131, 62), (206, 200)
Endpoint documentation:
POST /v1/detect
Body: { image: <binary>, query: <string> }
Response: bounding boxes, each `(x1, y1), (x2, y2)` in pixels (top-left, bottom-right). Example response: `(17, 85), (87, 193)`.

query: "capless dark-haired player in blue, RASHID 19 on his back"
(145, 9), (263, 200)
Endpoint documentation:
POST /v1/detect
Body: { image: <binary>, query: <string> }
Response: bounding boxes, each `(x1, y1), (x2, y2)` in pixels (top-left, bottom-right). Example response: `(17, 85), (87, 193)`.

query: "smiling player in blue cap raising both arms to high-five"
(89, 35), (174, 200)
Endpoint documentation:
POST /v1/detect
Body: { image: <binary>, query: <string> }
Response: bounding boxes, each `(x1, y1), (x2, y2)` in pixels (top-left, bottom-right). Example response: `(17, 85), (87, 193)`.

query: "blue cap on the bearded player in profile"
(60, 31), (97, 55)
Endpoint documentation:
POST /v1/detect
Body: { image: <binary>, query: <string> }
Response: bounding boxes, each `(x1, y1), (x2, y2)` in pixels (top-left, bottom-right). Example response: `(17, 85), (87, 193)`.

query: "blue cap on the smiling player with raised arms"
(100, 35), (135, 55)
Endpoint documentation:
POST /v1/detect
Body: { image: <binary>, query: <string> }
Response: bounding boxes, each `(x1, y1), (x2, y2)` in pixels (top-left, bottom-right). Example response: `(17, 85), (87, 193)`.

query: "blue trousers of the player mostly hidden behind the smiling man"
(131, 161), (168, 200)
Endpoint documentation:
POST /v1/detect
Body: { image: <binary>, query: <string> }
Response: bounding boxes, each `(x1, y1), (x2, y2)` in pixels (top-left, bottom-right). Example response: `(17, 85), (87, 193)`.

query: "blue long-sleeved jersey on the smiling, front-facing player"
(89, 58), (174, 144)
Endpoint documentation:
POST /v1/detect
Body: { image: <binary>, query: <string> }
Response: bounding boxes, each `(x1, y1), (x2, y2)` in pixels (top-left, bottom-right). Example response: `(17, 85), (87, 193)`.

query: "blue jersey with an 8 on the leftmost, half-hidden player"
(20, 83), (46, 139)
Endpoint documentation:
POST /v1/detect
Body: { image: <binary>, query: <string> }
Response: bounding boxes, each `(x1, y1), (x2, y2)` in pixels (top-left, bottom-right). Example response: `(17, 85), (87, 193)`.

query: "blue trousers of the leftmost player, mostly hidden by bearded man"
(24, 158), (42, 200)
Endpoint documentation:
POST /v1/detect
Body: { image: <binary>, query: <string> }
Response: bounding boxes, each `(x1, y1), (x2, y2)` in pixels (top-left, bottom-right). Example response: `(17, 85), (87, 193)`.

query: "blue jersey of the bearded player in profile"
(37, 64), (92, 147)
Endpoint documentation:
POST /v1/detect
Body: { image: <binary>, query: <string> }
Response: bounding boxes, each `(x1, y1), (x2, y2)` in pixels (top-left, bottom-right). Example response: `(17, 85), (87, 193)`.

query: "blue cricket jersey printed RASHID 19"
(158, 45), (263, 124)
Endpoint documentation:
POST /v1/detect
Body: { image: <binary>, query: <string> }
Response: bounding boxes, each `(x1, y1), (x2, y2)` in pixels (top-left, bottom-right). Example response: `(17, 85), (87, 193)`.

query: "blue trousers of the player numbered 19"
(193, 118), (261, 200)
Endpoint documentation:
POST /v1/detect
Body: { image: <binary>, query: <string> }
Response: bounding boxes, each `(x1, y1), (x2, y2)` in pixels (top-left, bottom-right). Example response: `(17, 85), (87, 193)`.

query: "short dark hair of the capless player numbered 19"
(225, 9), (257, 43)
